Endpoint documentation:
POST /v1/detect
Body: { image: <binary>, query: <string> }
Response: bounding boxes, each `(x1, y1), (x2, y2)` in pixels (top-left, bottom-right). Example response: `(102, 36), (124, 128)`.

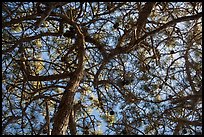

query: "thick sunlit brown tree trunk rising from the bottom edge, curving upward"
(52, 24), (85, 135)
